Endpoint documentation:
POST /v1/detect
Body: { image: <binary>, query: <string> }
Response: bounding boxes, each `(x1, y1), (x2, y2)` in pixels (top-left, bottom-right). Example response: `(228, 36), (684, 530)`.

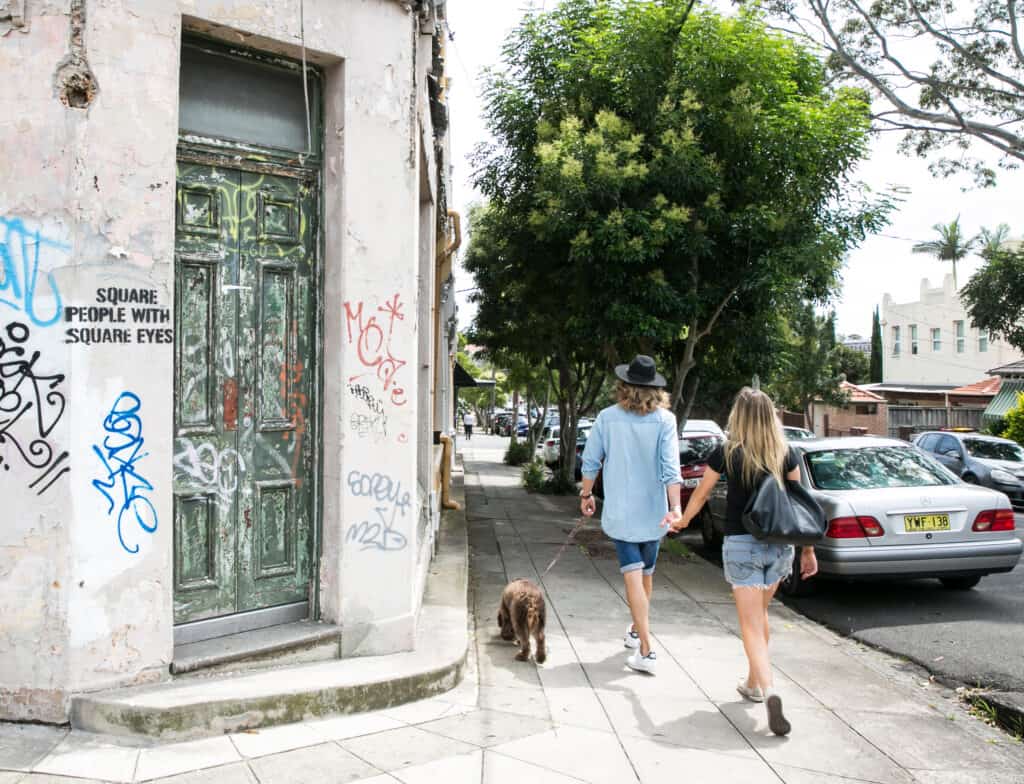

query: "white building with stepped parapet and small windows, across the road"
(882, 275), (1022, 387)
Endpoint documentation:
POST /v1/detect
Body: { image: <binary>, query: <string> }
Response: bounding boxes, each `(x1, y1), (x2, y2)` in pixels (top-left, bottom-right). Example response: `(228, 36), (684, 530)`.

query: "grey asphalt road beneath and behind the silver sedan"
(683, 515), (1024, 692)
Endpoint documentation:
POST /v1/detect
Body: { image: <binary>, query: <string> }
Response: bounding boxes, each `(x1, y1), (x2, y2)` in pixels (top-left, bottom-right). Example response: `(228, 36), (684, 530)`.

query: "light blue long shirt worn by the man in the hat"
(583, 405), (680, 541)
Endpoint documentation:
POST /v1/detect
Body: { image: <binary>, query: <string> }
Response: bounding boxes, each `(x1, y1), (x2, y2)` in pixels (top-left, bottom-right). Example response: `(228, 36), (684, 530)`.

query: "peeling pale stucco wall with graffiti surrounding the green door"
(0, 0), (440, 721)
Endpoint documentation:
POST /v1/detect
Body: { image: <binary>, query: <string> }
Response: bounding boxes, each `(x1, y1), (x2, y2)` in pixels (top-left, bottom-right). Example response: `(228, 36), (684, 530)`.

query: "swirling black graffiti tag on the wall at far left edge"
(0, 321), (71, 495)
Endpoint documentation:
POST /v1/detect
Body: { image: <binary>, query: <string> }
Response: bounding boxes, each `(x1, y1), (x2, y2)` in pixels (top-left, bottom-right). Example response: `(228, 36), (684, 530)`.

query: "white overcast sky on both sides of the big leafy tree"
(447, 0), (1024, 335)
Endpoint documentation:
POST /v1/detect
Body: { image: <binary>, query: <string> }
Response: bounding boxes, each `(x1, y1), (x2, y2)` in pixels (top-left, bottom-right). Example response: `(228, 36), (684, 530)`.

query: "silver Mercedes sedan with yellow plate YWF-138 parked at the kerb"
(701, 437), (1024, 595)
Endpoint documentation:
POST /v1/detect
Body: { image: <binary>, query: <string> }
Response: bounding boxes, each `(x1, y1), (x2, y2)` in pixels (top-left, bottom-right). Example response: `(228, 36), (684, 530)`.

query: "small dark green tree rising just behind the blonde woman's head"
(769, 303), (847, 427)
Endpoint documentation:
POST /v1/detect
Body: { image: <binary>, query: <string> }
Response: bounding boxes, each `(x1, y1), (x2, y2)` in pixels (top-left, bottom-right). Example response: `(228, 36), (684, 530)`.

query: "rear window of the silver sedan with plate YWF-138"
(807, 446), (956, 490)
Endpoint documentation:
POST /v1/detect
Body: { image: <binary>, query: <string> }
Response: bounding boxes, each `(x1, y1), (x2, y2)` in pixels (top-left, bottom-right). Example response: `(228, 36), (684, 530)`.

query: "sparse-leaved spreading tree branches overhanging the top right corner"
(757, 0), (1024, 184)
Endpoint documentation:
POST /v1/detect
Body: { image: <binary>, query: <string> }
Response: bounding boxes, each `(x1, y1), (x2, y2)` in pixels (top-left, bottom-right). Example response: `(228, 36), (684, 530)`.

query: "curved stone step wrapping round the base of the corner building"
(71, 475), (469, 741)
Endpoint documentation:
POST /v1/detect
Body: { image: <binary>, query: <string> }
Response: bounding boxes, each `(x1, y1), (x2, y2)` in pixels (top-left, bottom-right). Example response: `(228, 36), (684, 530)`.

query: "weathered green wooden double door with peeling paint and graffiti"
(174, 163), (317, 623)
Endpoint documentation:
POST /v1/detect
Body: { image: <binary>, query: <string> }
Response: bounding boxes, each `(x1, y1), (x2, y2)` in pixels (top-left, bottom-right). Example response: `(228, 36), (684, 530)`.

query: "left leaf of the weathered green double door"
(173, 163), (242, 623)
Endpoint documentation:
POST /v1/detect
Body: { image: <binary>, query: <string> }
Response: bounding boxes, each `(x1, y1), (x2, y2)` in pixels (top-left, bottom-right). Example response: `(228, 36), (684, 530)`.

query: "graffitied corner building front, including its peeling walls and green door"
(0, 0), (459, 722)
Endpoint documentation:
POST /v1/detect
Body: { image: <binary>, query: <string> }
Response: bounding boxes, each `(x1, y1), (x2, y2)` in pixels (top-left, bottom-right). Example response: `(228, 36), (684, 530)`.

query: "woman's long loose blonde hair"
(725, 387), (788, 487)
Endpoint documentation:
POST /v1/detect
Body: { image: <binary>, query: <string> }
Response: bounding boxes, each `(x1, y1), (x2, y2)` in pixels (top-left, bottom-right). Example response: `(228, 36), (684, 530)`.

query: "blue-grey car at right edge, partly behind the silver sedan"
(913, 431), (1024, 512)
